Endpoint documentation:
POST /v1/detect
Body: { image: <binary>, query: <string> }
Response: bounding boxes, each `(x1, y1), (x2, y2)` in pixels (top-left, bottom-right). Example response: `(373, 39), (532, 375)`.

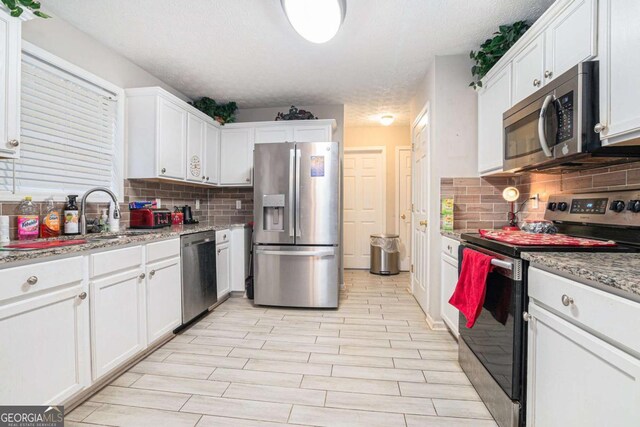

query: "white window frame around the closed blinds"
(0, 40), (125, 202)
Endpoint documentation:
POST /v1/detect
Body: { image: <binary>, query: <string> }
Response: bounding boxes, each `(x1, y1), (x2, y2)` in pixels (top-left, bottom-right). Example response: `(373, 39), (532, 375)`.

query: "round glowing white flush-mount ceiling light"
(281, 0), (347, 43)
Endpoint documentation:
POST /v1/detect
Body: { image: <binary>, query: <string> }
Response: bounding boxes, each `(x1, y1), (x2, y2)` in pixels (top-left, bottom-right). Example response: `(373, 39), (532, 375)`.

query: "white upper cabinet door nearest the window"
(157, 98), (187, 179)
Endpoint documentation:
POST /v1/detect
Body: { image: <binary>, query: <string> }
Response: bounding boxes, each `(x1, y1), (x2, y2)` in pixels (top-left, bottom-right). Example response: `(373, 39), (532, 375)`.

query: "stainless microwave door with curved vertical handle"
(503, 90), (558, 172)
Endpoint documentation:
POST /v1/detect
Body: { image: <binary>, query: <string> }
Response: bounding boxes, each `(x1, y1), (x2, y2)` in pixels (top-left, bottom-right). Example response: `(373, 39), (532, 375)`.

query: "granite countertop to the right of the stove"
(522, 252), (640, 299)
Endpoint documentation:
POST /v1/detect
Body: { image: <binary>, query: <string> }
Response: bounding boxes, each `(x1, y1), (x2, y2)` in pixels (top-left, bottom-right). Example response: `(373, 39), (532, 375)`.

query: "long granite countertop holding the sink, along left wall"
(0, 222), (244, 268)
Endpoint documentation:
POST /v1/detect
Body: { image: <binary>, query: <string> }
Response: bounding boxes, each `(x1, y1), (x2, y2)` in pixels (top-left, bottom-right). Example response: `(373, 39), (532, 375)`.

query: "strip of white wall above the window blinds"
(22, 17), (190, 101)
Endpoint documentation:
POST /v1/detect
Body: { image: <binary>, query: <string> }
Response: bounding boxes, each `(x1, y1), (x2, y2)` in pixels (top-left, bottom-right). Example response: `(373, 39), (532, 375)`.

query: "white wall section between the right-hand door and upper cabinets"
(411, 55), (478, 326)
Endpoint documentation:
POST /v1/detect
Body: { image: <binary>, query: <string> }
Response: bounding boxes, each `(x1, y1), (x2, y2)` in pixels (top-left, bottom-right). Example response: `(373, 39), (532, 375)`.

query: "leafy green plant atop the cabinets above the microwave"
(469, 21), (529, 89)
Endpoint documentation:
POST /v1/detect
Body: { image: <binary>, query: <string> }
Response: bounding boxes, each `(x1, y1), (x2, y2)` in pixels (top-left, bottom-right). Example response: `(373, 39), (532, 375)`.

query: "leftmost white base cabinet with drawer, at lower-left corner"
(0, 258), (91, 405)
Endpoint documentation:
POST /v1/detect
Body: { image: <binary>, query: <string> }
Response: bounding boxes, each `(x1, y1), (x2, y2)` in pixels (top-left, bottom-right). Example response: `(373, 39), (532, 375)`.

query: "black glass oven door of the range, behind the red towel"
(459, 243), (527, 401)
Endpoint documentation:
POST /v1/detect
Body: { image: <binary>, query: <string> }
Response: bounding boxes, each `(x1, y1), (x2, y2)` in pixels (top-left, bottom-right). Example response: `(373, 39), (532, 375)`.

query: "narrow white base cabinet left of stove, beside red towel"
(440, 237), (460, 337)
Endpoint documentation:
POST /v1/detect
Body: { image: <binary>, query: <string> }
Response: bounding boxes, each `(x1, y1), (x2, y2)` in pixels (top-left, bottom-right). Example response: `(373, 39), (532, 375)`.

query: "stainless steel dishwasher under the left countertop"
(180, 231), (218, 324)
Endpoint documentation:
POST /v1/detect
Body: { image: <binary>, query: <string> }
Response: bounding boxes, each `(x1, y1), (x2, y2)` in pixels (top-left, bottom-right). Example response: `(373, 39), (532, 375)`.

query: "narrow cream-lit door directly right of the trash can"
(396, 147), (411, 271)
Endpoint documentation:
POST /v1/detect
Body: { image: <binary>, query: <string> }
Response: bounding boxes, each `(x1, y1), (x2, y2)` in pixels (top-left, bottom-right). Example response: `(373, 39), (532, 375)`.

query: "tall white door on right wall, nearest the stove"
(411, 115), (430, 301)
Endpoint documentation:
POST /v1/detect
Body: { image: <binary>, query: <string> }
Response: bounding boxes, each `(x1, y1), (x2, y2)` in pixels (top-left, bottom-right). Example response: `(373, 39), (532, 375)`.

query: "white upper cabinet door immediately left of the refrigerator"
(220, 125), (253, 186)
